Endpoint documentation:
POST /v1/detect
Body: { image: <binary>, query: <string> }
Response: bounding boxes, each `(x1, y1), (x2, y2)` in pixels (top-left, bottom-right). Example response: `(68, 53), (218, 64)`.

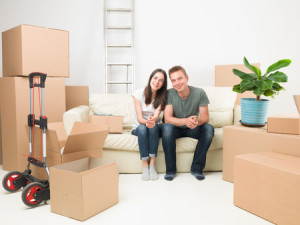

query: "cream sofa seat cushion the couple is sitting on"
(103, 128), (223, 152)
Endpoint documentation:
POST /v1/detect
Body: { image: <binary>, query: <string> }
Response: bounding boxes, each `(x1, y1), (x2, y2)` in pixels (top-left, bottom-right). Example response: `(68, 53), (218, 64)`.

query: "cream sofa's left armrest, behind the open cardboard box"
(63, 105), (90, 135)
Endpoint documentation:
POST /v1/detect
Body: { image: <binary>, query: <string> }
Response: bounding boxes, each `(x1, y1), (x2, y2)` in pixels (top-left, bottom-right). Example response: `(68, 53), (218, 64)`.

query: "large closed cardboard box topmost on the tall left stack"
(2, 25), (69, 77)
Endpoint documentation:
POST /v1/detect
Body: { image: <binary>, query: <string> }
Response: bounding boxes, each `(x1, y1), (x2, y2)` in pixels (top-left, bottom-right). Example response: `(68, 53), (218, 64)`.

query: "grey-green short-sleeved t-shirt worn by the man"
(167, 86), (209, 128)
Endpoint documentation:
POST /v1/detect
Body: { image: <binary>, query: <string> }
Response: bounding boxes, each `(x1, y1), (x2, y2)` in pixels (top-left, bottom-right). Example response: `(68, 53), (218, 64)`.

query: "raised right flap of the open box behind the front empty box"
(63, 122), (108, 154)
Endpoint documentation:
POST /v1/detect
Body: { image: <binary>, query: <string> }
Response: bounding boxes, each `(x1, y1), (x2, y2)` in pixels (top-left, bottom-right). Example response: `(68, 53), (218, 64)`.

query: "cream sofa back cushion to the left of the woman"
(89, 94), (135, 128)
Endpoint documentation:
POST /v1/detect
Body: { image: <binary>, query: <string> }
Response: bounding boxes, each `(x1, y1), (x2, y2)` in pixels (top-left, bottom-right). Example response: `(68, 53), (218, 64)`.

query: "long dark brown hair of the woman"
(144, 69), (168, 111)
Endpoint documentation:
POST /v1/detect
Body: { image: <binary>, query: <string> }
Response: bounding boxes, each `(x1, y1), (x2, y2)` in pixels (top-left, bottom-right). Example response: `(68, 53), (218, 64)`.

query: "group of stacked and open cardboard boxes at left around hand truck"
(0, 25), (118, 221)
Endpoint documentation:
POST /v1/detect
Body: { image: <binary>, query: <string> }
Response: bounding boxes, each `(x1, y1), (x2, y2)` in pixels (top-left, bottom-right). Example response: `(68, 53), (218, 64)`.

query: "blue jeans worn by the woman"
(131, 124), (162, 160)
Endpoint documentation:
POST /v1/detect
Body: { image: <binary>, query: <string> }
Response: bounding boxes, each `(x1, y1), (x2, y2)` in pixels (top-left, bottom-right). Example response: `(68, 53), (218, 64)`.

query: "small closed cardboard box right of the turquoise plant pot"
(267, 114), (300, 134)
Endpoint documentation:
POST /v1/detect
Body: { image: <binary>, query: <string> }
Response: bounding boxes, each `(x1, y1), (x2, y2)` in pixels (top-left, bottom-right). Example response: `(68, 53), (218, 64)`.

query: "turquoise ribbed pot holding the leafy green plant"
(241, 98), (269, 126)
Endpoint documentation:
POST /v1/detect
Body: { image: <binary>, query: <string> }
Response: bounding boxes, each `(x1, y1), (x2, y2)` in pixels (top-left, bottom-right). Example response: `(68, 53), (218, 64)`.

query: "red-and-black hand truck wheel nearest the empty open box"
(22, 182), (45, 208)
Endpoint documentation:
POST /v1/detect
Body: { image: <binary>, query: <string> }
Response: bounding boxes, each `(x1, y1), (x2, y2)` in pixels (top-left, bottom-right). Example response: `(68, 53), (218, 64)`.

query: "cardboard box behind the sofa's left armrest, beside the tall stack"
(66, 86), (89, 111)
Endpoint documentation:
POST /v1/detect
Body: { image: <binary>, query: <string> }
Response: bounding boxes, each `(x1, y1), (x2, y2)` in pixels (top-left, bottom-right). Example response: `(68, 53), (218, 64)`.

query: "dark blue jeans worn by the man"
(162, 123), (215, 174)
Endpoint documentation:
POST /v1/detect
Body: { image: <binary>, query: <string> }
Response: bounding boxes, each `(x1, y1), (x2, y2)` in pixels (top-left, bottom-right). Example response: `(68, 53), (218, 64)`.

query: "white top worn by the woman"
(132, 89), (162, 129)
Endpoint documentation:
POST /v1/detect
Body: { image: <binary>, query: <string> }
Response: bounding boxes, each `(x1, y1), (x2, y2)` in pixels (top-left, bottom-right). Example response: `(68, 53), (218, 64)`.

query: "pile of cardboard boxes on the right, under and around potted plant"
(223, 96), (300, 225)
